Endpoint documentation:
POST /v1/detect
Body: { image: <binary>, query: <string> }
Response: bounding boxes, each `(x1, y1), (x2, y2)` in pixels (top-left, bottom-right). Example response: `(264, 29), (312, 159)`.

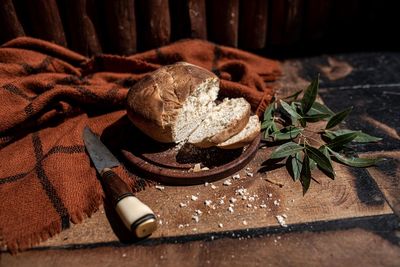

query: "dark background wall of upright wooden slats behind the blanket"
(0, 0), (400, 57)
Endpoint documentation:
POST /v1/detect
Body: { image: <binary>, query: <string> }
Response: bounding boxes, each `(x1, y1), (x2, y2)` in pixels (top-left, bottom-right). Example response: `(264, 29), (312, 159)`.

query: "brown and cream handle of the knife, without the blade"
(101, 168), (157, 238)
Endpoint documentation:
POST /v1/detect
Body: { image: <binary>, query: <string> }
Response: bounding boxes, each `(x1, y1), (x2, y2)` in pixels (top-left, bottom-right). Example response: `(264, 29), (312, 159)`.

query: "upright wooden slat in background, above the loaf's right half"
(187, 0), (207, 39)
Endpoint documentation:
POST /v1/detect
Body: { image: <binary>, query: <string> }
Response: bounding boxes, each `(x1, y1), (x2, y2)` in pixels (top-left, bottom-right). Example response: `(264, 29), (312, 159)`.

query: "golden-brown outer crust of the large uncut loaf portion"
(126, 62), (219, 143)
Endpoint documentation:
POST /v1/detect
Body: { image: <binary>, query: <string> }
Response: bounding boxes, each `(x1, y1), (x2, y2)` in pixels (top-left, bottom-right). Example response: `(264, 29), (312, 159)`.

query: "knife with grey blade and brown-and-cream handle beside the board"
(83, 126), (157, 238)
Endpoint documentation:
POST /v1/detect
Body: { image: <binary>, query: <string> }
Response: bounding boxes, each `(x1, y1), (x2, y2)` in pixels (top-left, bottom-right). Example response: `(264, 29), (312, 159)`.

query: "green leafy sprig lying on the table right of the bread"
(261, 76), (383, 194)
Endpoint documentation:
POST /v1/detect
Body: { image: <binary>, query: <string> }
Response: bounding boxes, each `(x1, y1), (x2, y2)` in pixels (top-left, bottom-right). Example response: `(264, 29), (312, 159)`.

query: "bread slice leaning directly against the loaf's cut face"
(188, 98), (250, 148)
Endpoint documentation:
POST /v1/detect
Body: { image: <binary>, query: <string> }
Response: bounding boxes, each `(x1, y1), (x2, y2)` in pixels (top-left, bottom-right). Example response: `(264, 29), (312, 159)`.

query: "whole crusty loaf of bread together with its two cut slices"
(127, 62), (260, 149)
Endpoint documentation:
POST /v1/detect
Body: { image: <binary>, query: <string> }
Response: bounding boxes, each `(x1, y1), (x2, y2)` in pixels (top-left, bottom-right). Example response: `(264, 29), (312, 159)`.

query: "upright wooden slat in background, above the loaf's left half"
(136, 0), (171, 50)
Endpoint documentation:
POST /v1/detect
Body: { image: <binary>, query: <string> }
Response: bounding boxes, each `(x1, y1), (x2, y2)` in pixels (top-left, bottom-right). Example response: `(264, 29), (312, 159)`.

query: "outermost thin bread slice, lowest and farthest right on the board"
(217, 115), (261, 149)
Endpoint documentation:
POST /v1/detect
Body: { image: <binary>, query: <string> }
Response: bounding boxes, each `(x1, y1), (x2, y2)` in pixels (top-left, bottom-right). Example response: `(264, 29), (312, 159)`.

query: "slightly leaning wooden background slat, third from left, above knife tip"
(59, 0), (102, 56)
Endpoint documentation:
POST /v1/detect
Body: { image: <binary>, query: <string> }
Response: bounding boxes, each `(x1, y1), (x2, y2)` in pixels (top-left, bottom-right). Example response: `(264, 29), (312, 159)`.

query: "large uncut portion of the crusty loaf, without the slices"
(126, 62), (219, 143)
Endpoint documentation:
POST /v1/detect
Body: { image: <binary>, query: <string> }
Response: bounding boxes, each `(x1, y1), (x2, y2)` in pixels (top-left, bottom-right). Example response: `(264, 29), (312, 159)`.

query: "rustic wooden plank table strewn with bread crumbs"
(0, 53), (400, 266)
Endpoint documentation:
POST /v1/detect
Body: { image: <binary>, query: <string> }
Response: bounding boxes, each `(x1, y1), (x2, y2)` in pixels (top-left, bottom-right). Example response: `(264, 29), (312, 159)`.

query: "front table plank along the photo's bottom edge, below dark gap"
(0, 229), (400, 267)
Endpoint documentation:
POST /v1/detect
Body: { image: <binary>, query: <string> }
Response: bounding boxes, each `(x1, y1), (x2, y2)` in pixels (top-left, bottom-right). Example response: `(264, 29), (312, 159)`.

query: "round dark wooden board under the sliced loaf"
(102, 117), (261, 185)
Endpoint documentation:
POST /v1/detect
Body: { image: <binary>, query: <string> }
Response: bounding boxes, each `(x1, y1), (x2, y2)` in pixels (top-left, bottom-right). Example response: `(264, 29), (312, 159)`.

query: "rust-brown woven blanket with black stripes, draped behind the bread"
(0, 37), (280, 251)
